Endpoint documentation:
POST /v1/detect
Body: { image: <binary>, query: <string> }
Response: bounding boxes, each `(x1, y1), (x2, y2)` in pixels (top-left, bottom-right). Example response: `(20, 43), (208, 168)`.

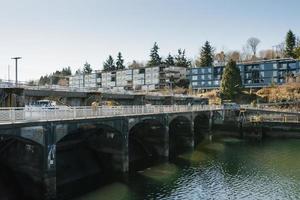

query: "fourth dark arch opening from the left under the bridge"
(169, 116), (194, 159)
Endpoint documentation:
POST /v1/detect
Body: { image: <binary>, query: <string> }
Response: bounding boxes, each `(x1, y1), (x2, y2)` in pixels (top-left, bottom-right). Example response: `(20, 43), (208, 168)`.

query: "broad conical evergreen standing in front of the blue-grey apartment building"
(221, 60), (242, 100)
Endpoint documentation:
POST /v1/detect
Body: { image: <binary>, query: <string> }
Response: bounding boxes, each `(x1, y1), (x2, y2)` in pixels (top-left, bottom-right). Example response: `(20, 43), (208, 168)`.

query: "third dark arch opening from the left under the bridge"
(128, 118), (168, 171)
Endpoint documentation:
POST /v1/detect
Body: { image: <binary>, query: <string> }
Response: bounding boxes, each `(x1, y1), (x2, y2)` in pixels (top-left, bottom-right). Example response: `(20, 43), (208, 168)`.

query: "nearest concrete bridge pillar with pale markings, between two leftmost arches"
(43, 123), (57, 200)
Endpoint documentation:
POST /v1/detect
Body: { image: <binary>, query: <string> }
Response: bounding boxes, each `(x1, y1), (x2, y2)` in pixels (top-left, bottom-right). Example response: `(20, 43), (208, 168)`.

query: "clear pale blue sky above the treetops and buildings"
(0, 0), (300, 81)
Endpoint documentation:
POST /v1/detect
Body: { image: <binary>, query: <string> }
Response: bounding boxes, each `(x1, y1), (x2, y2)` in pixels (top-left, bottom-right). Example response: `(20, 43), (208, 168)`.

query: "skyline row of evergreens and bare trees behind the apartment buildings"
(39, 30), (300, 85)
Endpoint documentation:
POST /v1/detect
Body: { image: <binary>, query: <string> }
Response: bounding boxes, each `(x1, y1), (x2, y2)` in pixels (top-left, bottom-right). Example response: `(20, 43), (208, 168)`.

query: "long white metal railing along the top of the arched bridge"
(0, 105), (221, 124)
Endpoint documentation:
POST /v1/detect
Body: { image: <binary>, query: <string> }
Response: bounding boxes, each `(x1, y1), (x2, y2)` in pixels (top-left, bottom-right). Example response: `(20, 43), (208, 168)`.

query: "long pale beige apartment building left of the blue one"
(69, 66), (186, 91)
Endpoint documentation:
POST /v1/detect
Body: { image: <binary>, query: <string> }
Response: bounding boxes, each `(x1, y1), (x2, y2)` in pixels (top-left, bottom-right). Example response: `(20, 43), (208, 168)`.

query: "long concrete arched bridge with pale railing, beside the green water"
(0, 105), (298, 200)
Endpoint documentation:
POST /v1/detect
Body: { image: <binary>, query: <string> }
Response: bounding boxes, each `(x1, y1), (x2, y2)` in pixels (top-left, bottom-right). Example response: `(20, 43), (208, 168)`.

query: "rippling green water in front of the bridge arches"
(76, 138), (300, 200)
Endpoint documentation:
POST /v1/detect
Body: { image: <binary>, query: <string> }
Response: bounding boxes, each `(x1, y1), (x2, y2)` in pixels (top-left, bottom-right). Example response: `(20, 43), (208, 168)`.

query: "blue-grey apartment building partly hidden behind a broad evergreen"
(187, 59), (300, 90)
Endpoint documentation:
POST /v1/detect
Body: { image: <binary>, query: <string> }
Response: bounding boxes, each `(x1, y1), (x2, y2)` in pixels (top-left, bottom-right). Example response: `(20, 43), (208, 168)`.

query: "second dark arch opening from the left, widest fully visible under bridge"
(56, 123), (124, 195)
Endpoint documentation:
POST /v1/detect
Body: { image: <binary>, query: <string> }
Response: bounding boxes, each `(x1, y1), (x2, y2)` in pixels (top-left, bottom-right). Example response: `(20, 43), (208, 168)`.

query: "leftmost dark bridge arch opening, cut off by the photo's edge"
(0, 135), (44, 199)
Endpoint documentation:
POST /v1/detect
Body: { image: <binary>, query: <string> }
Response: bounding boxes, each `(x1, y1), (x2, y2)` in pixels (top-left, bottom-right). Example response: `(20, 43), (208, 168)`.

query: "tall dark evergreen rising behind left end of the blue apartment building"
(196, 41), (214, 67)
